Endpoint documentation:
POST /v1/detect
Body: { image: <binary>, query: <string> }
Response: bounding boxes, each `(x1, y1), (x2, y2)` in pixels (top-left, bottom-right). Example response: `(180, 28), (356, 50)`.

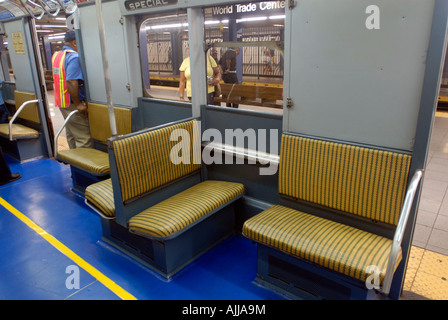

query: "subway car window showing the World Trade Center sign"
(204, 1), (285, 113)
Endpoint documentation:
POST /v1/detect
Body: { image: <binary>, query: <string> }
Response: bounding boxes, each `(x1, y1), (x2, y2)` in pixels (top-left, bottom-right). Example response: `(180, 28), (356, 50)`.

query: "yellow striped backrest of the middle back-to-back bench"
(113, 120), (202, 202)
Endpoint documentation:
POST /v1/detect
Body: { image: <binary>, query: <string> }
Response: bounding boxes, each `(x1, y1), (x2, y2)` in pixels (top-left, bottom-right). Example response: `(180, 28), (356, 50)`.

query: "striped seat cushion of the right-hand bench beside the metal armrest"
(243, 205), (401, 282)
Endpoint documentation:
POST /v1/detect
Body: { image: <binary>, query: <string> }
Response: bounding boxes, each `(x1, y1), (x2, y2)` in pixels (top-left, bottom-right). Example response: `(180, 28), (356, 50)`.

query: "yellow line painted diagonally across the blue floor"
(0, 197), (137, 300)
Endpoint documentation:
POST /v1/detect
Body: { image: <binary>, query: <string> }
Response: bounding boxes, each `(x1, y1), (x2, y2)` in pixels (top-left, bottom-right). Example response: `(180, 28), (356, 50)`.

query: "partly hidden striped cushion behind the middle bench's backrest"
(85, 178), (115, 218)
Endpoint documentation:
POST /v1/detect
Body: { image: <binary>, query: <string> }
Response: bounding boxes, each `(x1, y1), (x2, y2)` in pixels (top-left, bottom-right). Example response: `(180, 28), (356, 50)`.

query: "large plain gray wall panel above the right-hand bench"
(284, 0), (434, 150)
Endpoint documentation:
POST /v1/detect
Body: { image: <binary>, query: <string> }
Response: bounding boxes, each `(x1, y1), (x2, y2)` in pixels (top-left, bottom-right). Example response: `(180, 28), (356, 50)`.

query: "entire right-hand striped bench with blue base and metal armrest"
(243, 134), (422, 299)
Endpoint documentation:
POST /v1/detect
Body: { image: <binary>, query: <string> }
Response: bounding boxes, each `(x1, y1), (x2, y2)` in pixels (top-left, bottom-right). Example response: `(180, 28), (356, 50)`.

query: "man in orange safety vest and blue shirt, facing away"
(52, 30), (92, 149)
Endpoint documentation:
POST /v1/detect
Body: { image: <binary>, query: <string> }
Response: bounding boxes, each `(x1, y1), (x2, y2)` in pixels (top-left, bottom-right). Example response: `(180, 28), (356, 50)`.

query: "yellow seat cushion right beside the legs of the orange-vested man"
(57, 148), (110, 176)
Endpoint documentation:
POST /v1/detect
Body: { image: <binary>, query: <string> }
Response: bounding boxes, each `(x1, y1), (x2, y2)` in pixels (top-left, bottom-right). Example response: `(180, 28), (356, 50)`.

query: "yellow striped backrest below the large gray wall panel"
(279, 134), (411, 225)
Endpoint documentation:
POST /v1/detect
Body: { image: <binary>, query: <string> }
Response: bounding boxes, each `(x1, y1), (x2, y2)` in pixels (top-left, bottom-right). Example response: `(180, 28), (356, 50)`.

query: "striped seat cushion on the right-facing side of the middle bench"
(129, 180), (244, 238)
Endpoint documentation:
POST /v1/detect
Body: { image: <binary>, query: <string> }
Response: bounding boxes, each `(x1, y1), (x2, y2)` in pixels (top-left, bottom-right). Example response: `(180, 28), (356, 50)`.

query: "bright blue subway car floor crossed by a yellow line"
(0, 159), (282, 300)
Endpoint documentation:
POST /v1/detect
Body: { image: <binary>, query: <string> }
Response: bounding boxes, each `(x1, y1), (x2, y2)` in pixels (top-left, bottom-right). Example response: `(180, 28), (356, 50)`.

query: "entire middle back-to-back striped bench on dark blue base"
(85, 119), (244, 279)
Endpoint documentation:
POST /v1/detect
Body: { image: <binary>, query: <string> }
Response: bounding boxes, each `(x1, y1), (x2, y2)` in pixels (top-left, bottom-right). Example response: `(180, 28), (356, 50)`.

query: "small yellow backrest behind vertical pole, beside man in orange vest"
(89, 103), (132, 143)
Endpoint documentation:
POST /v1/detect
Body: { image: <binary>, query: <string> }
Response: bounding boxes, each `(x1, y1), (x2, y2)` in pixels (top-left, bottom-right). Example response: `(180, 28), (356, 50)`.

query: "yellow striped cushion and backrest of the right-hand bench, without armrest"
(243, 134), (412, 295)
